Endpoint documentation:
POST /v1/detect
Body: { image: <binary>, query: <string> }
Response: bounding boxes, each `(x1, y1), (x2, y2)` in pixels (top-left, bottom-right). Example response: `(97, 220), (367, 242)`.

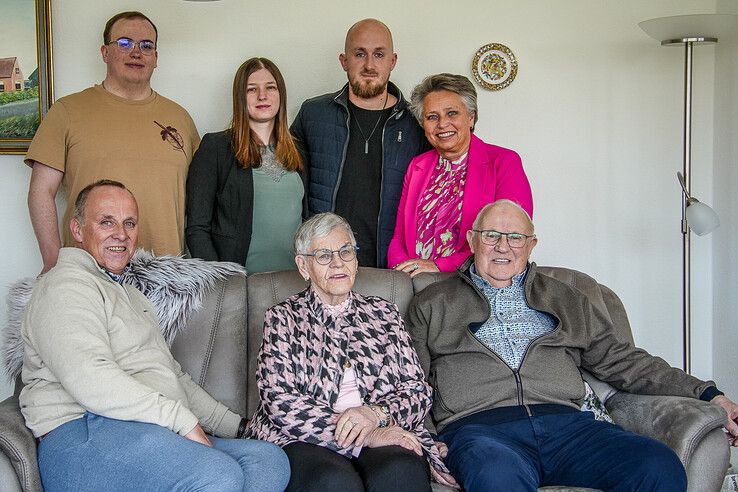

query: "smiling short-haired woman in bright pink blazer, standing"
(387, 73), (533, 277)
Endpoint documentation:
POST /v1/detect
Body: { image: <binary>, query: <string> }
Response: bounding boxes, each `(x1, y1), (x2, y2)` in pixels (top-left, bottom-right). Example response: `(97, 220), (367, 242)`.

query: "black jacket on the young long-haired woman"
(185, 130), (304, 265)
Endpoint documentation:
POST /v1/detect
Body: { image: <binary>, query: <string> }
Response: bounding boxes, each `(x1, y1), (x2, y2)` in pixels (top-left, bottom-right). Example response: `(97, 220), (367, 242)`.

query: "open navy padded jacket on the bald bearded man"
(290, 82), (430, 267)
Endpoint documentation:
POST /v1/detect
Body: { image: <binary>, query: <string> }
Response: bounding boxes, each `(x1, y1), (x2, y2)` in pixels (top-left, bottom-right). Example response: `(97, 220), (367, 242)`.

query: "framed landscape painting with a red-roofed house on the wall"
(0, 0), (53, 154)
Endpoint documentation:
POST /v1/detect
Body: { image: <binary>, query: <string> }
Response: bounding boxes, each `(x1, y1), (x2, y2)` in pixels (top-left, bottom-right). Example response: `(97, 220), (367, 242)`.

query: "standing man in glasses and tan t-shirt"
(25, 12), (200, 273)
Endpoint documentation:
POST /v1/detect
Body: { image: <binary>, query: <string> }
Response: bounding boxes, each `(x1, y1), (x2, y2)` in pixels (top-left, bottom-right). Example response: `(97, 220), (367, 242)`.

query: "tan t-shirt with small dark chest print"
(25, 85), (200, 255)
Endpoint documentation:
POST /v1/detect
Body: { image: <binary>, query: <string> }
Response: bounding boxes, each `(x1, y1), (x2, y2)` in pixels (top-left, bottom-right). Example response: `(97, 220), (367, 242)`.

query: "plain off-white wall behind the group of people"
(0, 0), (736, 404)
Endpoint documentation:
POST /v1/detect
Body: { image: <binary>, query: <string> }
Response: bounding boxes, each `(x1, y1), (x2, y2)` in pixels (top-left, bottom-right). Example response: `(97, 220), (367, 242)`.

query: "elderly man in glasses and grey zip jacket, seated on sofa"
(408, 200), (738, 492)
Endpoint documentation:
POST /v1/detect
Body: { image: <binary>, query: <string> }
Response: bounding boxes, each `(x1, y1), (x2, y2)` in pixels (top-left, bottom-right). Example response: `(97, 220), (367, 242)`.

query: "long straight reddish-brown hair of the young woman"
(231, 58), (302, 171)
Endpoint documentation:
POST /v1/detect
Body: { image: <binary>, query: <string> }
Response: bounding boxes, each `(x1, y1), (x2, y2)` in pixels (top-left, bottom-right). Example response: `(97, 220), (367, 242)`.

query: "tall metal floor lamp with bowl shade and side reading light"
(638, 14), (738, 373)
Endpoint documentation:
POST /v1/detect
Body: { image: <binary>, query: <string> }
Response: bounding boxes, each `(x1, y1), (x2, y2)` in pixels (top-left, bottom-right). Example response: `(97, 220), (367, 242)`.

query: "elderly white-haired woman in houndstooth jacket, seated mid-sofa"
(247, 213), (455, 492)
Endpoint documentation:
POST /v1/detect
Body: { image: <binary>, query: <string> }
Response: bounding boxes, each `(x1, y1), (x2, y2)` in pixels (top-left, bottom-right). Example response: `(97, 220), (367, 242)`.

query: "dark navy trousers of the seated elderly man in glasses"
(439, 411), (687, 492)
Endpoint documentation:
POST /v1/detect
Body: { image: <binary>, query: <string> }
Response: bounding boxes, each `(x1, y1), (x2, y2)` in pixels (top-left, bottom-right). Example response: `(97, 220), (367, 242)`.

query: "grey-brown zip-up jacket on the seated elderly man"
(407, 258), (715, 431)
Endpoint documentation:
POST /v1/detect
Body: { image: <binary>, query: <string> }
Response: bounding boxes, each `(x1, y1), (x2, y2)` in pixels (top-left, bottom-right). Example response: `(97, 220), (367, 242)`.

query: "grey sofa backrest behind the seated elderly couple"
(172, 267), (633, 417)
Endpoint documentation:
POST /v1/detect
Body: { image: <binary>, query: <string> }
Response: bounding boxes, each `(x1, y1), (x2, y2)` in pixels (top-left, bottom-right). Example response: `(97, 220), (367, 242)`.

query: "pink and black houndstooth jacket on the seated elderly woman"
(247, 289), (447, 472)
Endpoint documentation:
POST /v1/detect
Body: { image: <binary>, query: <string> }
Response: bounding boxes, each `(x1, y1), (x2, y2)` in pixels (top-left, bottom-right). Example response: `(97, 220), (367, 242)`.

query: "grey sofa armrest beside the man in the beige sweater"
(0, 396), (42, 492)
